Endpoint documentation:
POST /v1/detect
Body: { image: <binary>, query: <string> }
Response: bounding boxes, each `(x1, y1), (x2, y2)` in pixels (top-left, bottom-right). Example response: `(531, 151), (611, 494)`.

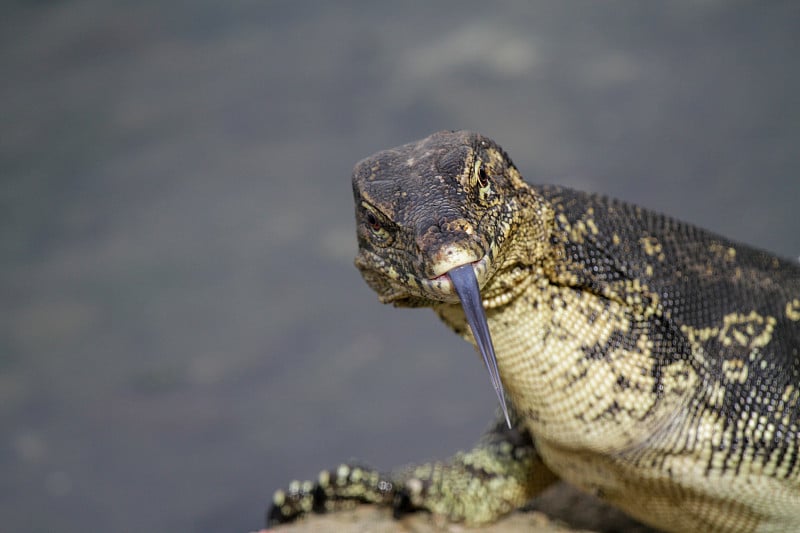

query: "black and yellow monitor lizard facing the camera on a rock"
(268, 132), (800, 531)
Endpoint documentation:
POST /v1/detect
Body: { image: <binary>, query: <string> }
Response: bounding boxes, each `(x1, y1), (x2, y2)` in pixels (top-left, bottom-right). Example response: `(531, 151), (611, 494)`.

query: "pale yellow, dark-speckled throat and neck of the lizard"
(436, 267), (696, 453)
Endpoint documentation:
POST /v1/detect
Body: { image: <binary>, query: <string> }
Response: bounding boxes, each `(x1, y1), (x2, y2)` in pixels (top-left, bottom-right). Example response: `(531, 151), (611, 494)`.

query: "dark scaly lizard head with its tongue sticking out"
(353, 131), (544, 427)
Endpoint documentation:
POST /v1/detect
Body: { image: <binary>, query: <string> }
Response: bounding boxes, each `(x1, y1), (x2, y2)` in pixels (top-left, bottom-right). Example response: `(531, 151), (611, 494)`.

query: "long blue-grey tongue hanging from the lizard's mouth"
(447, 265), (511, 428)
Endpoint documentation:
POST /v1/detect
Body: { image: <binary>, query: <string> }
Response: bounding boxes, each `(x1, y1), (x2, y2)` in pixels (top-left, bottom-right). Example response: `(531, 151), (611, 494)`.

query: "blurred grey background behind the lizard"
(0, 0), (800, 533)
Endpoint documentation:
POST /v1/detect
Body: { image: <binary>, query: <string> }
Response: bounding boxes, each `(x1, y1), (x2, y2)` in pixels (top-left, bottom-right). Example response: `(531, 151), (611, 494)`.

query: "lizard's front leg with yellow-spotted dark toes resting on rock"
(267, 412), (556, 525)
